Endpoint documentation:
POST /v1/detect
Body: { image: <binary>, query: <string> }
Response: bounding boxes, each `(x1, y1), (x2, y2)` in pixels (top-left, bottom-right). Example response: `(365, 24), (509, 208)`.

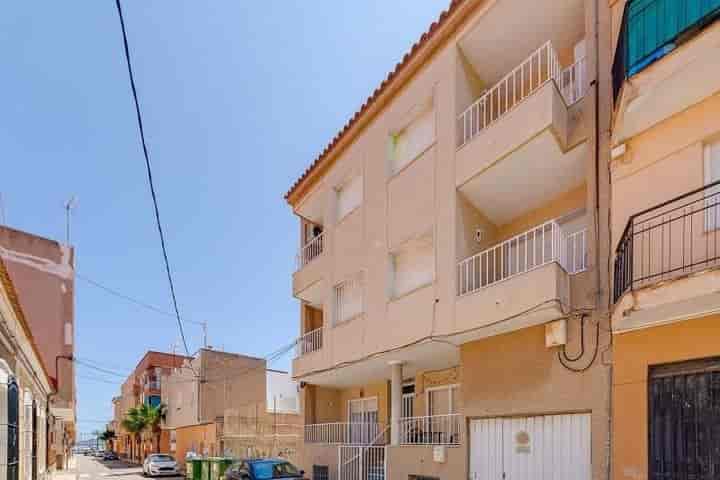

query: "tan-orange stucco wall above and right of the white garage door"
(461, 318), (610, 480)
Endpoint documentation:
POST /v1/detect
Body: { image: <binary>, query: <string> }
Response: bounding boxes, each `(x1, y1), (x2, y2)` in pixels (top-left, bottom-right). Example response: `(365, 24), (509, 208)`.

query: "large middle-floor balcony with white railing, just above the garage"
(456, 220), (587, 341)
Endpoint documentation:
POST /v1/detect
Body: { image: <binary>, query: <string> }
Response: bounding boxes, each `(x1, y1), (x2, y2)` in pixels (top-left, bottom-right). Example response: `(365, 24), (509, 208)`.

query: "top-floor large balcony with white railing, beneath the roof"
(455, 42), (587, 224)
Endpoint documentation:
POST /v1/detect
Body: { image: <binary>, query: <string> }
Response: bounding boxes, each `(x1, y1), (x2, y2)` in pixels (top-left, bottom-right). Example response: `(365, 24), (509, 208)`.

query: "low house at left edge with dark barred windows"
(0, 251), (54, 480)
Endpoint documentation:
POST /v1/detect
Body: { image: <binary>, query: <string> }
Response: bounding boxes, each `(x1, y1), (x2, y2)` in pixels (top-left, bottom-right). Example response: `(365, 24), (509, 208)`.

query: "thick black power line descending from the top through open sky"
(115, 0), (190, 356)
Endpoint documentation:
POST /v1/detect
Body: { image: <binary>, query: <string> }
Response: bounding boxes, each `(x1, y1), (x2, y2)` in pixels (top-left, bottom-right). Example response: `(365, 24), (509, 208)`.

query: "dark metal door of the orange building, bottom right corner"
(648, 359), (720, 480)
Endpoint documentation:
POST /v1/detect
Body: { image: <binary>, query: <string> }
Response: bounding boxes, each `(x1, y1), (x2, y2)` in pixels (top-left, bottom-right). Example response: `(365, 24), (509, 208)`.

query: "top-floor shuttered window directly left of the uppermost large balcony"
(390, 104), (435, 173)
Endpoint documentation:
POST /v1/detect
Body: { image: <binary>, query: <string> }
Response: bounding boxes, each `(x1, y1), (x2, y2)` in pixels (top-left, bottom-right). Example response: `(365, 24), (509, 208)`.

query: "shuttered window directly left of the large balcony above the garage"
(391, 235), (435, 298)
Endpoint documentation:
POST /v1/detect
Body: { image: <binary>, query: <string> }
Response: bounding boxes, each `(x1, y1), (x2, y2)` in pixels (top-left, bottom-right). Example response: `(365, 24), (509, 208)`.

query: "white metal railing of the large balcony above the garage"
(457, 220), (587, 296)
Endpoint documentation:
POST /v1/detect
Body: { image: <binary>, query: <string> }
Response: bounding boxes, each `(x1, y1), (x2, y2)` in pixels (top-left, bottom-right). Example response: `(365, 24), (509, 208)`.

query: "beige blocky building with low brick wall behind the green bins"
(162, 348), (300, 464)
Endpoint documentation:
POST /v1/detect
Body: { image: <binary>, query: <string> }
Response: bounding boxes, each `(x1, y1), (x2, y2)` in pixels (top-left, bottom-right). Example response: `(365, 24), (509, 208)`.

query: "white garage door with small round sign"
(470, 414), (591, 480)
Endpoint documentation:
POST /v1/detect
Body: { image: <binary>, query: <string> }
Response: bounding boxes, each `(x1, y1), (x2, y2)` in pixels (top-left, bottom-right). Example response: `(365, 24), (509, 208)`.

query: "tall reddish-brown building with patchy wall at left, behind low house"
(0, 227), (76, 469)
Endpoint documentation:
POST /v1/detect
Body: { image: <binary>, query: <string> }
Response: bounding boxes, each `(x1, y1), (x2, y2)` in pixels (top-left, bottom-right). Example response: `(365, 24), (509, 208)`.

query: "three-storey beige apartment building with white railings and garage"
(286, 0), (611, 480)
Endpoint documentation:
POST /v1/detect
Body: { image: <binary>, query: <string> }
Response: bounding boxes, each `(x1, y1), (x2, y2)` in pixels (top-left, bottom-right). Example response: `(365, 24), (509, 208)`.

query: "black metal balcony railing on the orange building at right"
(613, 181), (720, 302)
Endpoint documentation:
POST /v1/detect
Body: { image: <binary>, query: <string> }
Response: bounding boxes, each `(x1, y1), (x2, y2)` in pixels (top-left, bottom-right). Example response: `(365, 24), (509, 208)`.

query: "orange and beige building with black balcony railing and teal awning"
(610, 0), (720, 480)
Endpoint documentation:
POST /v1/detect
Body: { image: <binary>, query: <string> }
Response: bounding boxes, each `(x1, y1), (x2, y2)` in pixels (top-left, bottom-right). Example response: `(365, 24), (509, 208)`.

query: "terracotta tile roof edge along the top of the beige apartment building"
(285, 0), (467, 200)
